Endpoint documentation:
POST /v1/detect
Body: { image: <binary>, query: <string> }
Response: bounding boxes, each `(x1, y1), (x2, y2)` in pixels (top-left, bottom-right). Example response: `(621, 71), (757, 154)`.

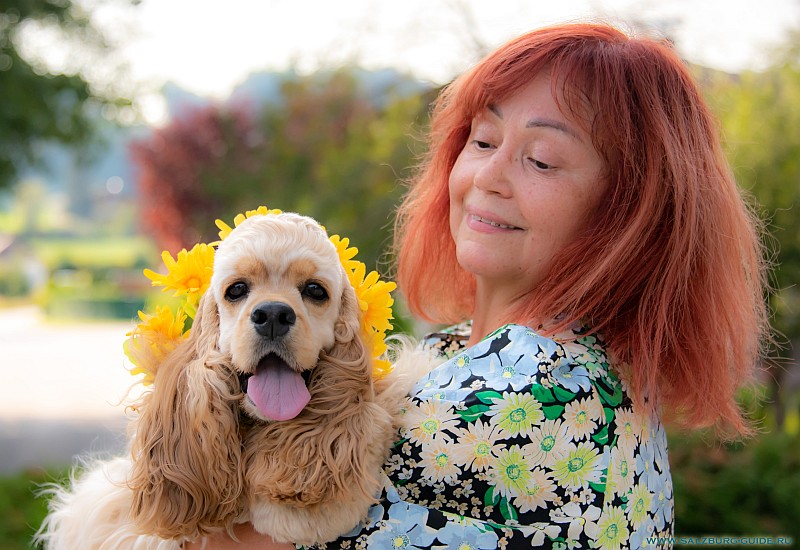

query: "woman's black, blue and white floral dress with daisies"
(310, 324), (673, 550)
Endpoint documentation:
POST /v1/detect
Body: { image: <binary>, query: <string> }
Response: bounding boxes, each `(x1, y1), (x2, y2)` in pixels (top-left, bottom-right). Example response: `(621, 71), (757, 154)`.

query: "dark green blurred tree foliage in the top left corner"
(0, 0), (133, 192)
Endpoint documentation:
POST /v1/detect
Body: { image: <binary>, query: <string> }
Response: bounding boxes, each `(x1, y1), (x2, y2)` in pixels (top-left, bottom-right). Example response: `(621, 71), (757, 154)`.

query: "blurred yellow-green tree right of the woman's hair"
(707, 32), (800, 432)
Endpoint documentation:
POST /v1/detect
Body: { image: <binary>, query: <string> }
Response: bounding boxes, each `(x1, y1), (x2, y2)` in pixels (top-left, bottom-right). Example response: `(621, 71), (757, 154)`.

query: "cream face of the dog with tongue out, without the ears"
(209, 213), (357, 421)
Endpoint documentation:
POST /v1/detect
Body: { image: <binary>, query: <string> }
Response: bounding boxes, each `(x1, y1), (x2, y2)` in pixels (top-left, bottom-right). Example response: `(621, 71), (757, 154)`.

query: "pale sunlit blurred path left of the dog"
(0, 307), (141, 474)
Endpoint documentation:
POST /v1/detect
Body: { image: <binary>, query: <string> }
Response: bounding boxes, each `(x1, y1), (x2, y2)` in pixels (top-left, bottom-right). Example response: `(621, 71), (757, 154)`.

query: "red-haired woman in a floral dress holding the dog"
(194, 24), (767, 549)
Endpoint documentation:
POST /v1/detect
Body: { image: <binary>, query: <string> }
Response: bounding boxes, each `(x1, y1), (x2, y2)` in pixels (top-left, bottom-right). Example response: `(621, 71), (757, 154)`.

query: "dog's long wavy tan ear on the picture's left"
(130, 292), (242, 539)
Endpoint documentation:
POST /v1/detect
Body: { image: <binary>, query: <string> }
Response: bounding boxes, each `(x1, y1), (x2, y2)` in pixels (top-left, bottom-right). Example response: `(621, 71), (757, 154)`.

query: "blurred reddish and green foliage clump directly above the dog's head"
(132, 70), (430, 274)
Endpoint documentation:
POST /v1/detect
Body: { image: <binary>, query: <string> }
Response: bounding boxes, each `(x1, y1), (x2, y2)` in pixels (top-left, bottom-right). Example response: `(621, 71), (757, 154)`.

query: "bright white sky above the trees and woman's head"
(87, 0), (800, 124)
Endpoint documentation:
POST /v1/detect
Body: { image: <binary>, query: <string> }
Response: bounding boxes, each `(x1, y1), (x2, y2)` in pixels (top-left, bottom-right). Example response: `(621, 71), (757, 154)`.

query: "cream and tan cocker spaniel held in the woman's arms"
(37, 213), (434, 550)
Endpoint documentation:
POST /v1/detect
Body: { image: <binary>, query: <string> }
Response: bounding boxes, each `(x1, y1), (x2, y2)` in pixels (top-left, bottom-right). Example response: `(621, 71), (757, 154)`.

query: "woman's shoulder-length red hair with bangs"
(395, 24), (768, 433)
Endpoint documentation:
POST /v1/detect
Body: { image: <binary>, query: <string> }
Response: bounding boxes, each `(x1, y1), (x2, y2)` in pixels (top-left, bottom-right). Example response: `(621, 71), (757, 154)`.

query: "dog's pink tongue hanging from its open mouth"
(247, 355), (311, 420)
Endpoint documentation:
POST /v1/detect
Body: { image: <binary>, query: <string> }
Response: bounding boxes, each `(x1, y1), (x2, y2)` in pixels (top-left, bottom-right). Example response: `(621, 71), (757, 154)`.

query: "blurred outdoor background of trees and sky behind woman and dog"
(0, 0), (800, 549)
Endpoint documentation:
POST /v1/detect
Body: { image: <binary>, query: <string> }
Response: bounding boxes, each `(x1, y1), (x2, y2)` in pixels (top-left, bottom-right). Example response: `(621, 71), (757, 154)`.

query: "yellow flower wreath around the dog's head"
(124, 206), (397, 385)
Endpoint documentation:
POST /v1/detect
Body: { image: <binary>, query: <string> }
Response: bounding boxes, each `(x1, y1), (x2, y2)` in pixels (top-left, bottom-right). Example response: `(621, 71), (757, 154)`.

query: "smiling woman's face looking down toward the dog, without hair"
(449, 73), (607, 302)
